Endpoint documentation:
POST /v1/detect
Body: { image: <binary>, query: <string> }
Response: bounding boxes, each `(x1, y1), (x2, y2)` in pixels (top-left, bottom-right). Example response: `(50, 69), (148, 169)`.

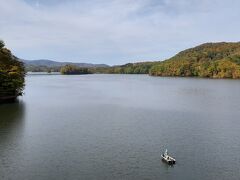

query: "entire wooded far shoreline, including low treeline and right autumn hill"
(27, 42), (240, 79)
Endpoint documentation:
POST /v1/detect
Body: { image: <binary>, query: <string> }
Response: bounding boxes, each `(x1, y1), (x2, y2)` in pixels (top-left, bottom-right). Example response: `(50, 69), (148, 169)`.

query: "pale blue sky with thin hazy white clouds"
(0, 0), (240, 65)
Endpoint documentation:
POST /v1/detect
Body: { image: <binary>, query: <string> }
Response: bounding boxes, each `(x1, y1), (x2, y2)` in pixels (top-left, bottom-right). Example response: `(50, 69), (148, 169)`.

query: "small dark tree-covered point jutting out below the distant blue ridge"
(60, 64), (91, 75)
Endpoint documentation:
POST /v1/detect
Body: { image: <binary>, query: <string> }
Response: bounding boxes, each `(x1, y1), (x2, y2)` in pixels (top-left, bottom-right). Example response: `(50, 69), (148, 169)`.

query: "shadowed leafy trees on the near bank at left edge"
(0, 40), (25, 102)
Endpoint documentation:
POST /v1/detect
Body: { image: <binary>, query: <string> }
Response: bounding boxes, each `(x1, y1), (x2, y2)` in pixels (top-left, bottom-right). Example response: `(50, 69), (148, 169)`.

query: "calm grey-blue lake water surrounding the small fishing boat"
(0, 75), (240, 180)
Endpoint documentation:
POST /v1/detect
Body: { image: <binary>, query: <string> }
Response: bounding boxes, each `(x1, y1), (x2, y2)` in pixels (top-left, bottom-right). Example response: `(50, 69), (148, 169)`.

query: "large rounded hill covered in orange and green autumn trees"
(149, 42), (240, 78)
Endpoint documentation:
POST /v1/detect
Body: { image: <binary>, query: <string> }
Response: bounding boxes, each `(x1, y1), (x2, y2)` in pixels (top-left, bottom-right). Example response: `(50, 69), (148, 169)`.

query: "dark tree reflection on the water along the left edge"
(0, 101), (25, 179)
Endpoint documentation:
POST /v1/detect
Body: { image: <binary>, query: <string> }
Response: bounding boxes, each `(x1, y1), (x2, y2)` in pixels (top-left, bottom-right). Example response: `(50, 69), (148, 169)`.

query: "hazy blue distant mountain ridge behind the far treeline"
(20, 59), (109, 68)
